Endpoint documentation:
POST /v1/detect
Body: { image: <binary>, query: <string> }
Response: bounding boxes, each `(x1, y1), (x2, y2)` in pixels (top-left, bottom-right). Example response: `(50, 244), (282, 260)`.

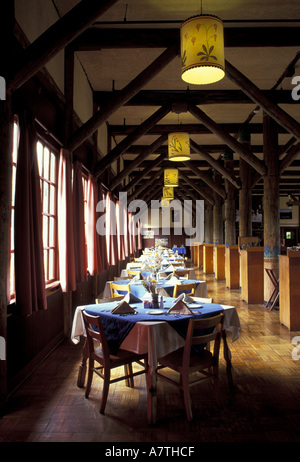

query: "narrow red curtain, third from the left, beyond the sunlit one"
(73, 162), (87, 282)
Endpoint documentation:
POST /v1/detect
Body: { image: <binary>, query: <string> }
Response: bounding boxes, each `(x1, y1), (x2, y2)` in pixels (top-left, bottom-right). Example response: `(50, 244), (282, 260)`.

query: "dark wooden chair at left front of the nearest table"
(82, 310), (148, 414)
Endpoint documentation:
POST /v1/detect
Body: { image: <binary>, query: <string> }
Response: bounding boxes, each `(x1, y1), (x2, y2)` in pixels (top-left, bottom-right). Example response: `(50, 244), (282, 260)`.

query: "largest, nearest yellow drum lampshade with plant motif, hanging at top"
(180, 14), (225, 85)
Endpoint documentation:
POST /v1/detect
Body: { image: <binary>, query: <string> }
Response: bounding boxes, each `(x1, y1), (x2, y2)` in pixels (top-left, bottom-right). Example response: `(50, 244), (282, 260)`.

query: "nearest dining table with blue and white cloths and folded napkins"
(71, 294), (241, 424)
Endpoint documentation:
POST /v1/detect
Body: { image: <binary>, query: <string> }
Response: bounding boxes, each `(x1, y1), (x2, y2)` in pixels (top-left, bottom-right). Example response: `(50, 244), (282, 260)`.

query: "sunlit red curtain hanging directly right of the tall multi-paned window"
(57, 149), (76, 292)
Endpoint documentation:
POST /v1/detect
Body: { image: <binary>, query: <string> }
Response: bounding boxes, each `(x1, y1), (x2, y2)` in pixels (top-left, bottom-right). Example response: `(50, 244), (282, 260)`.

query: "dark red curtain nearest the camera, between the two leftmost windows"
(14, 114), (47, 316)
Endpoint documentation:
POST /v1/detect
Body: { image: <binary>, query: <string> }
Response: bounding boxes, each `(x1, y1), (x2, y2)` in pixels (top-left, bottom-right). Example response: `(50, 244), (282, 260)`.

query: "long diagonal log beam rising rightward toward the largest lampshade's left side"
(68, 46), (178, 151)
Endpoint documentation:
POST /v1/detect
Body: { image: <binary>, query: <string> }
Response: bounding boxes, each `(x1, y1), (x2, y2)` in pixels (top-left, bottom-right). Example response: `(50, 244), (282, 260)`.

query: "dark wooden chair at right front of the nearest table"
(156, 313), (224, 421)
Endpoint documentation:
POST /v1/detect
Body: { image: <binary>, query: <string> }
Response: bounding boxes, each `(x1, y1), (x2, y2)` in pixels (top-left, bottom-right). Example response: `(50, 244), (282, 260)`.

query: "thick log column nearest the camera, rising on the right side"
(263, 114), (280, 302)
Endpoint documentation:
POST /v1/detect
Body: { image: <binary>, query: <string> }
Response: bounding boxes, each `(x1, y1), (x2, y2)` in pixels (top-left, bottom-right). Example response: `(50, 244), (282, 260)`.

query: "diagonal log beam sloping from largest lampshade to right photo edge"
(225, 61), (300, 141)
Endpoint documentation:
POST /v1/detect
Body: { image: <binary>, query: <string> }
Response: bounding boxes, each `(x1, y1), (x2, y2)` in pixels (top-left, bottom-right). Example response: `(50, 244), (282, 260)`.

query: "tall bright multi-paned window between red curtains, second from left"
(37, 139), (58, 285)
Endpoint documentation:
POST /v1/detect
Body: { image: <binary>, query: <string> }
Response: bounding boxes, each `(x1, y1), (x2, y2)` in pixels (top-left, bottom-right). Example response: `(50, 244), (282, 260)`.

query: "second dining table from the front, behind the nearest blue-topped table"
(102, 277), (207, 298)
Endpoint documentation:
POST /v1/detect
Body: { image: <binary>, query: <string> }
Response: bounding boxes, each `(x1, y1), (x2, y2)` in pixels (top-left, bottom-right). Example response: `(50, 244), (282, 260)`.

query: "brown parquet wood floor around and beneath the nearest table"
(0, 264), (300, 443)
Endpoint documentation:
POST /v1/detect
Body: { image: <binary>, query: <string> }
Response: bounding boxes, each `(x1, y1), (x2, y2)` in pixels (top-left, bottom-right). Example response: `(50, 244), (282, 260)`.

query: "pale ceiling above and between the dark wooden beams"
(53, 0), (300, 205)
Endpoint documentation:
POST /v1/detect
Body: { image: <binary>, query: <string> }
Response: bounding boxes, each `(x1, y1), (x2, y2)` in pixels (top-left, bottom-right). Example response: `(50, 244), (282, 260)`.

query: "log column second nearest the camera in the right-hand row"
(239, 128), (253, 237)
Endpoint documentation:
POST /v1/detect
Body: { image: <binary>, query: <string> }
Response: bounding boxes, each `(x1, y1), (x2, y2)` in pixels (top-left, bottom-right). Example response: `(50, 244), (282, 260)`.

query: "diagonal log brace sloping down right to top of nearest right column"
(189, 106), (267, 175)
